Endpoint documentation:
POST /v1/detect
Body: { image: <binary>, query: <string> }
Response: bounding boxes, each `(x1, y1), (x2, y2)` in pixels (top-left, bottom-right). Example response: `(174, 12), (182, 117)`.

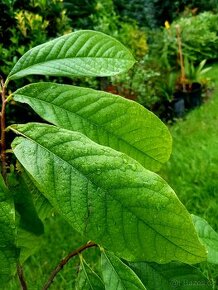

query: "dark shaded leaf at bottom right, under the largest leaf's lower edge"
(129, 262), (212, 290)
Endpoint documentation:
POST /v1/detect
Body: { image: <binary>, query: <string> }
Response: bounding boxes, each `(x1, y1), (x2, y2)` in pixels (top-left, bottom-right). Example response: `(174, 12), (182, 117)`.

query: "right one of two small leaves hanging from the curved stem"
(101, 251), (146, 290)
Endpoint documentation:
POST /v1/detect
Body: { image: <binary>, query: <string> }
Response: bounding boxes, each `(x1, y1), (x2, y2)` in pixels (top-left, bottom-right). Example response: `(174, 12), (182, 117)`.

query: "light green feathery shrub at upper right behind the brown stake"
(153, 12), (218, 67)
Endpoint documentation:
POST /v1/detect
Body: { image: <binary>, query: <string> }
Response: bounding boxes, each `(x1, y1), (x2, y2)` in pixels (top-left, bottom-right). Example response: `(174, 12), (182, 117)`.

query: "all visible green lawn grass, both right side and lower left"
(5, 65), (218, 290)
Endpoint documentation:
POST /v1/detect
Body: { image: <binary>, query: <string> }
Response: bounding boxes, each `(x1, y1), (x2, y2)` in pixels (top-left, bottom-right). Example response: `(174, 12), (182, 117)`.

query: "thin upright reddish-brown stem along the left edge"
(0, 78), (7, 181)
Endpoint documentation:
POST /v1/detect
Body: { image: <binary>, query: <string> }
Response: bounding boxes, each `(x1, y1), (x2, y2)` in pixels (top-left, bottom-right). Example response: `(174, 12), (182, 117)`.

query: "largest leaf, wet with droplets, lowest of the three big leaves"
(11, 123), (206, 263)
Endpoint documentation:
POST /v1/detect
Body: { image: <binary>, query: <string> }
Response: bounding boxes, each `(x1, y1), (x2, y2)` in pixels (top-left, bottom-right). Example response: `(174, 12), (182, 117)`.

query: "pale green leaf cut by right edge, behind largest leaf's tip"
(192, 214), (218, 264)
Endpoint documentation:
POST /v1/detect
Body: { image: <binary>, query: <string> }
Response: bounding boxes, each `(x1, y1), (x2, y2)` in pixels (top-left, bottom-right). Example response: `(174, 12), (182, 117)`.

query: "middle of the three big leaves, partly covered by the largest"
(14, 83), (172, 171)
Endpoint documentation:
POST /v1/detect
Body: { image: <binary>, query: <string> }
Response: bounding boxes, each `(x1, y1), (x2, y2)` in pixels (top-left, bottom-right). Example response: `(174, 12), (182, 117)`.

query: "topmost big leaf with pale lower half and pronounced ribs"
(8, 30), (135, 80)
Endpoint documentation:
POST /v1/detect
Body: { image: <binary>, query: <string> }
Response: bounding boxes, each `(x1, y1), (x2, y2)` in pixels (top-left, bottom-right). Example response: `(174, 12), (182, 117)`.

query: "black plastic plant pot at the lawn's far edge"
(176, 83), (202, 109)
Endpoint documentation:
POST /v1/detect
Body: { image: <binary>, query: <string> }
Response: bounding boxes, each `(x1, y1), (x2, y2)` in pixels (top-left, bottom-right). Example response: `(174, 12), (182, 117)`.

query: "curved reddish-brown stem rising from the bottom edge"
(42, 242), (97, 290)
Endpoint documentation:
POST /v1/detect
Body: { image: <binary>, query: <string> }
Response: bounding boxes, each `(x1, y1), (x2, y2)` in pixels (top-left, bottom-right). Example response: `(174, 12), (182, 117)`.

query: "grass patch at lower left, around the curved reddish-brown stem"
(7, 216), (99, 290)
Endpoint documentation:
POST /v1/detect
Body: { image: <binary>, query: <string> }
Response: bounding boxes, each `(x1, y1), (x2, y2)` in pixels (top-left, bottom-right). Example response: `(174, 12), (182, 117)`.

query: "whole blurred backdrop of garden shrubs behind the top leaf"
(0, 0), (218, 114)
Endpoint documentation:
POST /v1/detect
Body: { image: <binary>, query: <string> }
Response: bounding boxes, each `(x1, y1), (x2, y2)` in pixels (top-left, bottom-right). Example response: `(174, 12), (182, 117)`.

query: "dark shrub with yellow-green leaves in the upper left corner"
(0, 0), (72, 76)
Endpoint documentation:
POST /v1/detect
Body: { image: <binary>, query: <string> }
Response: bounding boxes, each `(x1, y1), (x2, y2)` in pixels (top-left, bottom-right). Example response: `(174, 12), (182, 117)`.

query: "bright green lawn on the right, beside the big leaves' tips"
(161, 65), (218, 289)
